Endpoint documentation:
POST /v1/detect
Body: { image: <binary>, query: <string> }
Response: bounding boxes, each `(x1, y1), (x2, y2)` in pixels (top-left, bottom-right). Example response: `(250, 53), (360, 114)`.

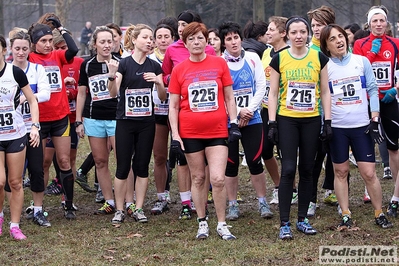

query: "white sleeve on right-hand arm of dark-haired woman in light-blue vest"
(248, 56), (266, 112)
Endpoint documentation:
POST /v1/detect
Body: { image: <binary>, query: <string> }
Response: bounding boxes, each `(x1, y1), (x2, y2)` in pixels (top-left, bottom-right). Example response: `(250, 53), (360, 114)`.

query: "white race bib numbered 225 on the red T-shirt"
(188, 80), (219, 112)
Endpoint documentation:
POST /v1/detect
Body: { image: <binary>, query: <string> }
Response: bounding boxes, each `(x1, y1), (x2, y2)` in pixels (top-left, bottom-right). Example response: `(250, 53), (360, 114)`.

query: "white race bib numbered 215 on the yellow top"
(286, 81), (316, 112)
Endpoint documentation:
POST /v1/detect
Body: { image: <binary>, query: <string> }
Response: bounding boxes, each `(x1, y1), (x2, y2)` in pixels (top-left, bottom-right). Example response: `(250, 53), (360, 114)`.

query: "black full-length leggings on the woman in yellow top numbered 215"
(277, 115), (321, 222)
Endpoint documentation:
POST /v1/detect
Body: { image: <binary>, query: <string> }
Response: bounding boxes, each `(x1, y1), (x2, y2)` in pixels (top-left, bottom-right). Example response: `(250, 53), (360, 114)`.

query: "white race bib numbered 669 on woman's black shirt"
(125, 88), (152, 117)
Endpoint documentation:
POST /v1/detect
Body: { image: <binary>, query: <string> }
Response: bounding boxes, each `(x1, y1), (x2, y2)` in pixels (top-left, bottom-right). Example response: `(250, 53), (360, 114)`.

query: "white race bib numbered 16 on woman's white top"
(332, 76), (362, 105)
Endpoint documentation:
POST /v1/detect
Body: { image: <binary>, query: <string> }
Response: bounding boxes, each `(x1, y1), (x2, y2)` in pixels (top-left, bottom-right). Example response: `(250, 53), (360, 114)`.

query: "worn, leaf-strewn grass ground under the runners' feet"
(0, 139), (399, 265)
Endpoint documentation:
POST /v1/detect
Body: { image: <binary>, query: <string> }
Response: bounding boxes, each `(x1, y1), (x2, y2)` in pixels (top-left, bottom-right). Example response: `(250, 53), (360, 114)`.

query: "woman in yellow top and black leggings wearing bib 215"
(268, 16), (332, 239)
